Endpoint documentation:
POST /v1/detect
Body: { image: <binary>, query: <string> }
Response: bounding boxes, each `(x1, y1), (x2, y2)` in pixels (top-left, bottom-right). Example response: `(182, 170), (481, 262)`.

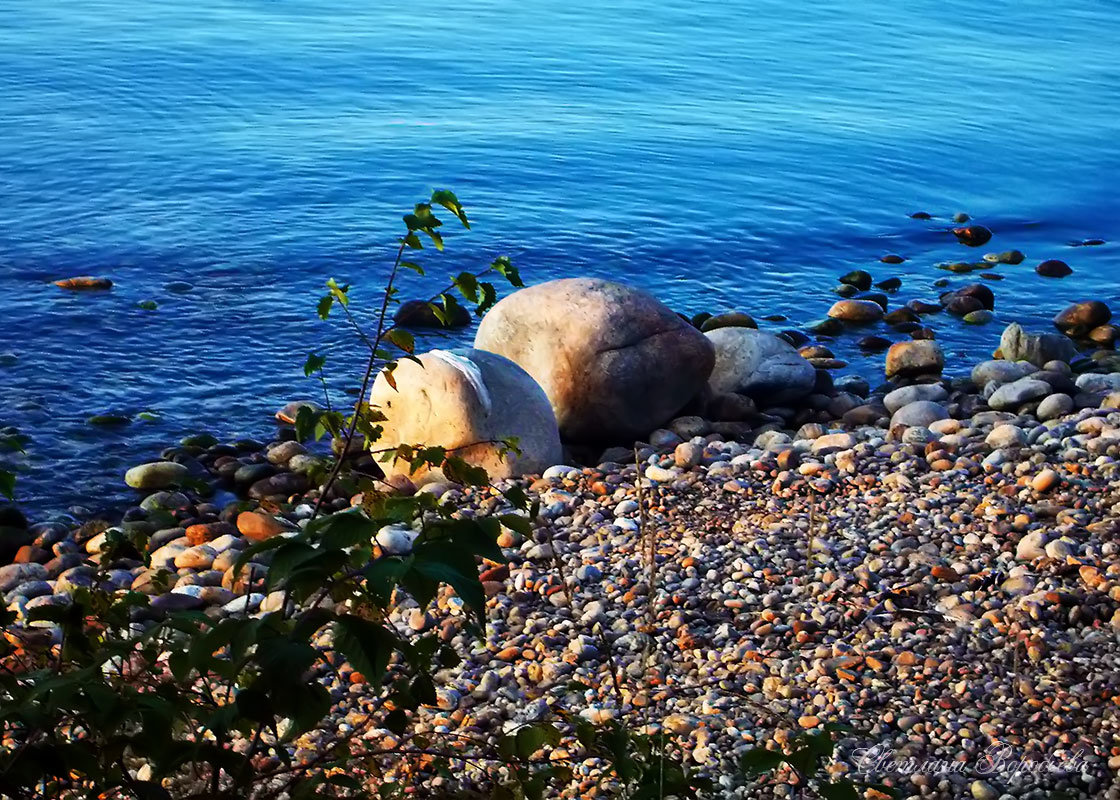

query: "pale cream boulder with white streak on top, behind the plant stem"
(370, 348), (561, 477)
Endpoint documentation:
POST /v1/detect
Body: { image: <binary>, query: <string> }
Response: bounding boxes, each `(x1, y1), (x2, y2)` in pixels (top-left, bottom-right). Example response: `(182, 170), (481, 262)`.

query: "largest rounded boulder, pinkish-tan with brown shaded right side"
(475, 278), (716, 443)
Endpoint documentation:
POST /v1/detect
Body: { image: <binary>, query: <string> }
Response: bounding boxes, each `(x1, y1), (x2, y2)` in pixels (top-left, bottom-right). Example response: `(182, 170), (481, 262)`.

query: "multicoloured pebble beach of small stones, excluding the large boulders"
(0, 338), (1120, 798)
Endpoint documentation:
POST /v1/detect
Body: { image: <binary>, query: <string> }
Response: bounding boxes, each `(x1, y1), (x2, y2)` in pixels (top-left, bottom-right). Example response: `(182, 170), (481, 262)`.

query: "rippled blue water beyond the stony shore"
(0, 0), (1120, 511)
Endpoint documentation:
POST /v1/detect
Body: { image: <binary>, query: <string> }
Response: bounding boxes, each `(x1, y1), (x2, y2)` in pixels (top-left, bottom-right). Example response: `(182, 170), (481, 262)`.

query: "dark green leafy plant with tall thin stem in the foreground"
(0, 190), (535, 798)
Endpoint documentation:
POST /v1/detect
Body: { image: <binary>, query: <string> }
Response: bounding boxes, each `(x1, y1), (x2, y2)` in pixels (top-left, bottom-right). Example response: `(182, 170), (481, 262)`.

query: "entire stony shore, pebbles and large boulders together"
(15, 242), (1120, 798)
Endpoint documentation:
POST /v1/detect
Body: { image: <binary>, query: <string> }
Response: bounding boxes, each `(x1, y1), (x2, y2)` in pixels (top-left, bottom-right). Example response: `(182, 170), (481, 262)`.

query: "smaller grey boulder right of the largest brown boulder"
(704, 328), (816, 406)
